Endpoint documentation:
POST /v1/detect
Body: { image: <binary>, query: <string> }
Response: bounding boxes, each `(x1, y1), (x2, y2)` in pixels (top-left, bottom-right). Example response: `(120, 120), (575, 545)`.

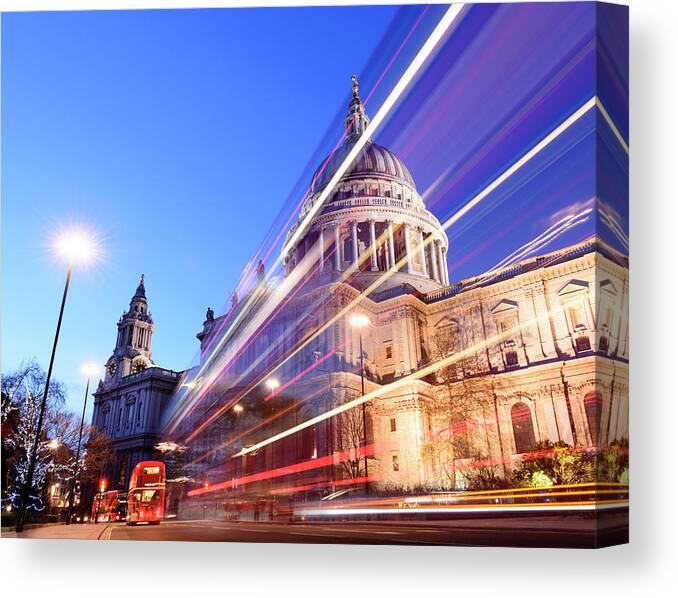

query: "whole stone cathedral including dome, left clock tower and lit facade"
(93, 85), (628, 516)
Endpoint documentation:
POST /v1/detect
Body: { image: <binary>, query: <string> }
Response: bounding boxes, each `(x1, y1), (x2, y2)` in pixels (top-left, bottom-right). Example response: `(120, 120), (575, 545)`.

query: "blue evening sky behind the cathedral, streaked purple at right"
(2, 3), (628, 418)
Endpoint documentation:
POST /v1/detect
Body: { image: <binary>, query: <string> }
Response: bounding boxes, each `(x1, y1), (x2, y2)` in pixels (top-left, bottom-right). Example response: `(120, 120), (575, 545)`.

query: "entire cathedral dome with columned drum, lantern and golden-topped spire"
(282, 76), (449, 292)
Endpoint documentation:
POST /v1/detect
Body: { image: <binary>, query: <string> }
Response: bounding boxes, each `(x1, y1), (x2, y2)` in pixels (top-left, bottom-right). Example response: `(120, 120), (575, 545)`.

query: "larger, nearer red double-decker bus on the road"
(127, 461), (165, 525)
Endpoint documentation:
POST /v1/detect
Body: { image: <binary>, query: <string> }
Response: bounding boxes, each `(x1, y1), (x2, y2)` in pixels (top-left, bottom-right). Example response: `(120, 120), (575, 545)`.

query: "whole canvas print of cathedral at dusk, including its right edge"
(2, 2), (629, 548)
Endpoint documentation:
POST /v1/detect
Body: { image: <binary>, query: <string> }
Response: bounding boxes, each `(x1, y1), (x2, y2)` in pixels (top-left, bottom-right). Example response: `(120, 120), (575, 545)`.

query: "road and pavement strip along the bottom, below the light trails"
(2, 512), (628, 548)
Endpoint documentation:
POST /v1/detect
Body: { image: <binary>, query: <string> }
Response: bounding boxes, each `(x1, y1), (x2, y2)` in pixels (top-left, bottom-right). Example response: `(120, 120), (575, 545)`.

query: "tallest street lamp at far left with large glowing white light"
(16, 231), (96, 532)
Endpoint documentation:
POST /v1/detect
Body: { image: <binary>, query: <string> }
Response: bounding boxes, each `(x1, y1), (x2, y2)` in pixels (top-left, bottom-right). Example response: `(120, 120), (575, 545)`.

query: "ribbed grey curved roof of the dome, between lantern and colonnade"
(311, 142), (414, 194)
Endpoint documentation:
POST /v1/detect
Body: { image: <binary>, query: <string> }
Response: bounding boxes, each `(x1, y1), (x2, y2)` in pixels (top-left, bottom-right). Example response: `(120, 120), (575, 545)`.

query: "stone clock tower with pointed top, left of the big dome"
(104, 274), (154, 384)
